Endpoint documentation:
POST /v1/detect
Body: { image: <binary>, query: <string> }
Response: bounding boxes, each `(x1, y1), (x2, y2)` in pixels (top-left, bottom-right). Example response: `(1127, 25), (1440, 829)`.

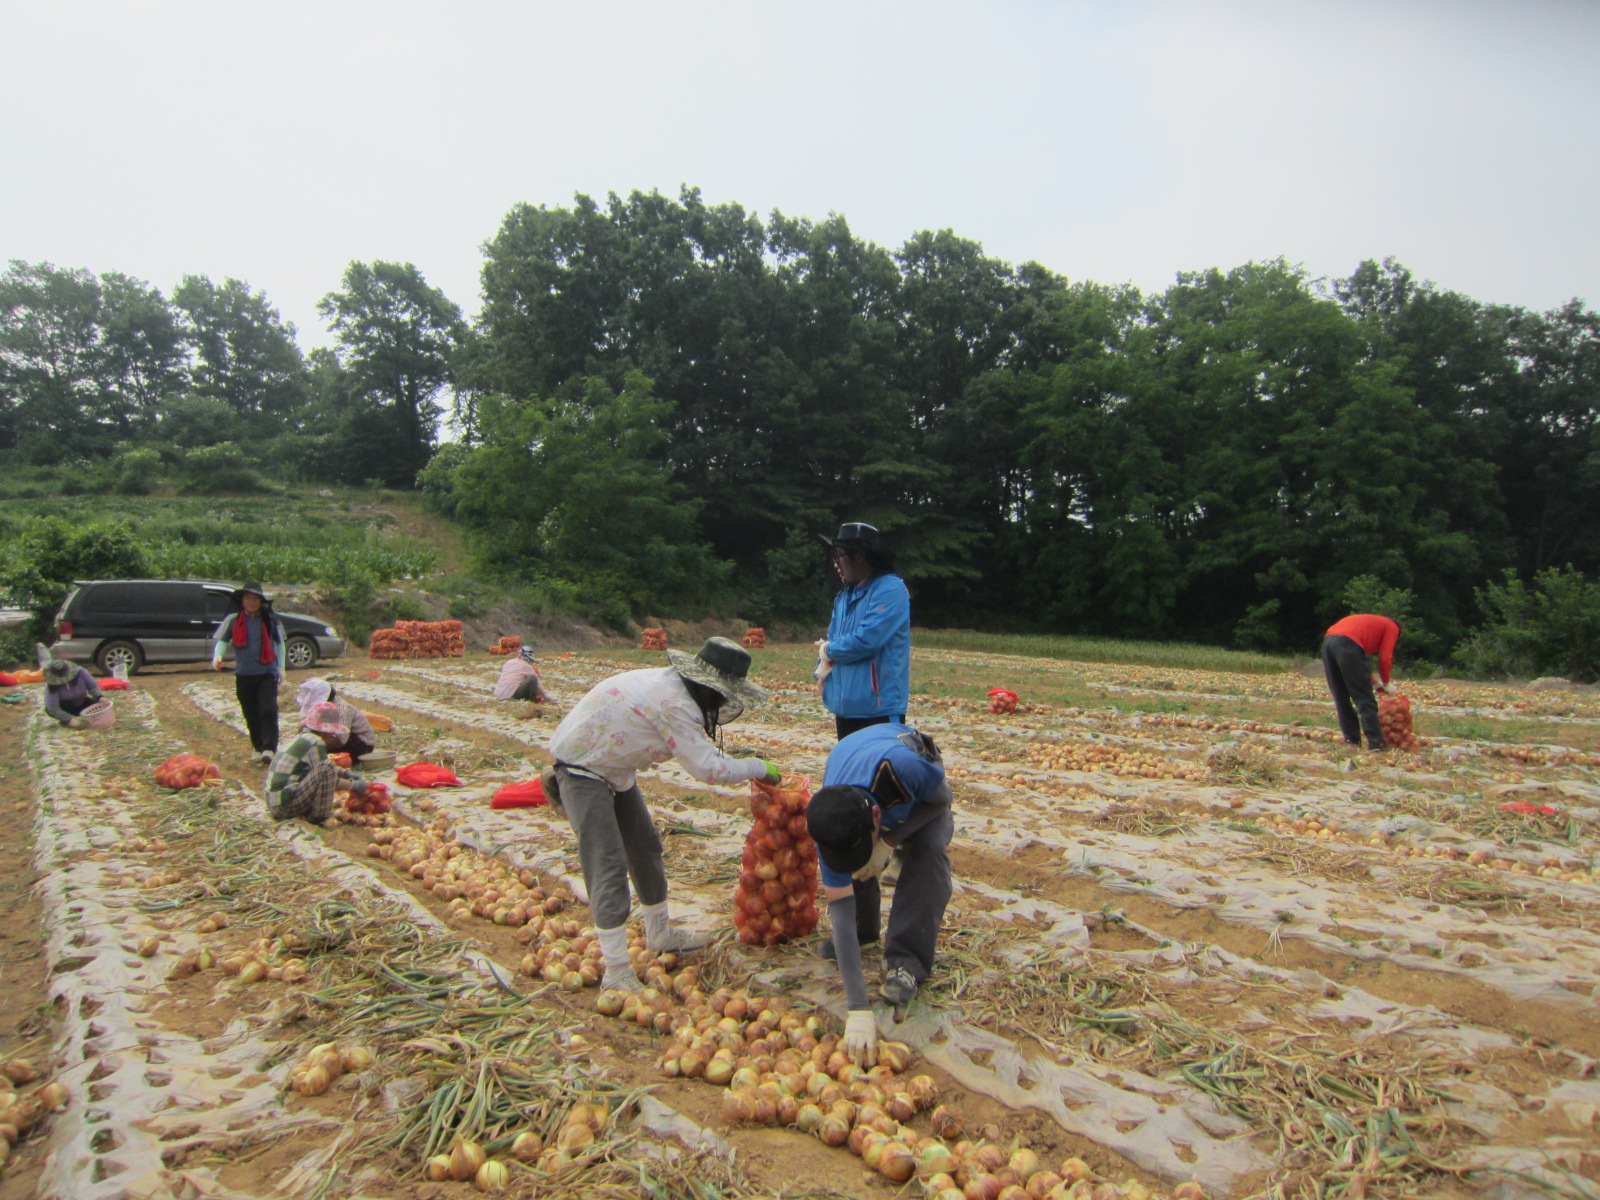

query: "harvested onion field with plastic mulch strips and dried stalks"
(0, 646), (1600, 1200)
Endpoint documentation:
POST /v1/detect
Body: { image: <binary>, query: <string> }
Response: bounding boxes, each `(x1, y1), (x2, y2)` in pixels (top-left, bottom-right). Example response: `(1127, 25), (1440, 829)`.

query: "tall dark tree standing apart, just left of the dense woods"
(317, 262), (467, 488)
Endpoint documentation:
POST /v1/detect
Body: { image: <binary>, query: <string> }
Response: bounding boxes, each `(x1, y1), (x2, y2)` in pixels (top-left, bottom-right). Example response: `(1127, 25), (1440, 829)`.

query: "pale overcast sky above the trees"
(0, 0), (1600, 349)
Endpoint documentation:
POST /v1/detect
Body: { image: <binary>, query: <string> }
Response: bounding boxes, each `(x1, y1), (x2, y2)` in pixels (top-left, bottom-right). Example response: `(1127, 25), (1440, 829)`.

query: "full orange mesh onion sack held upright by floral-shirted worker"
(733, 774), (818, 946)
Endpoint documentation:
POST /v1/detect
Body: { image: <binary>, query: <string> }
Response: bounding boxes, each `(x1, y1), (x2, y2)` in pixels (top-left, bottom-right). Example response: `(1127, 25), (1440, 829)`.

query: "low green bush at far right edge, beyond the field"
(1454, 565), (1600, 683)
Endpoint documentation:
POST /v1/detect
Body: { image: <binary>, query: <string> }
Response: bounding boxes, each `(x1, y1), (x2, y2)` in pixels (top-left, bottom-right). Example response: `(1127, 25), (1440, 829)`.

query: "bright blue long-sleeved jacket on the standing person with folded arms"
(822, 574), (910, 717)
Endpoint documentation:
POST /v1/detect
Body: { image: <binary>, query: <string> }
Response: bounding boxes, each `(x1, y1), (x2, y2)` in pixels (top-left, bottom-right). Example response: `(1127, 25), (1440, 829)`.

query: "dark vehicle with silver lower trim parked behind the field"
(50, 579), (344, 675)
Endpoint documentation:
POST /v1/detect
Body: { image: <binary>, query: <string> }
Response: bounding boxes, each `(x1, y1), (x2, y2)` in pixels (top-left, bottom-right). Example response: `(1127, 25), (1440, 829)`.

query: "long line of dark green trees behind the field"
(0, 189), (1600, 672)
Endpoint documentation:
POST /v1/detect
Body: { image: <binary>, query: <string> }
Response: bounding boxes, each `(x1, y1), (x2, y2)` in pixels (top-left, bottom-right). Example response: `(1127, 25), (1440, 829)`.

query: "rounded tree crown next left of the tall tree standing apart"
(173, 275), (306, 434)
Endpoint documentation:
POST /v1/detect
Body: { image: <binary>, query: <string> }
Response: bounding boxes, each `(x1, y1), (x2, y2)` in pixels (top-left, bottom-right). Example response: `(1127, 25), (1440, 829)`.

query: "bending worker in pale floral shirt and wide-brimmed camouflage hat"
(544, 637), (782, 992)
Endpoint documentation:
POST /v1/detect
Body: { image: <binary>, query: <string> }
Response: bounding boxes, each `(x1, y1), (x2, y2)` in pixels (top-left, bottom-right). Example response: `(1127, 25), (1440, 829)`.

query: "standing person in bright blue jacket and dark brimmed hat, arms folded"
(816, 522), (910, 738)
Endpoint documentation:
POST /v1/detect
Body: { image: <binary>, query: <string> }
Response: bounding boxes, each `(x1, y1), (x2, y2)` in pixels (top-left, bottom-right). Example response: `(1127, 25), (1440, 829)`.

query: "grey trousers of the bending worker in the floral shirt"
(555, 766), (667, 930)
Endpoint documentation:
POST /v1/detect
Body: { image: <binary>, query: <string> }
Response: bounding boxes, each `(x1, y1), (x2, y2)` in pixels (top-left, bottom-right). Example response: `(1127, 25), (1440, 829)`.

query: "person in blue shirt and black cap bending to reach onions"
(806, 725), (955, 1064)
